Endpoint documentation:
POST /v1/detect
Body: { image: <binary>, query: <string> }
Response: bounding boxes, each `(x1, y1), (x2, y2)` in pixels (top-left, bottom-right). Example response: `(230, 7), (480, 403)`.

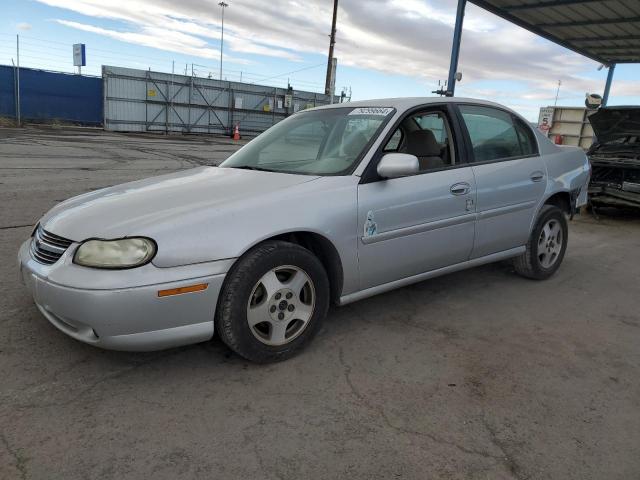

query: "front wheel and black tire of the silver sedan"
(215, 240), (330, 363)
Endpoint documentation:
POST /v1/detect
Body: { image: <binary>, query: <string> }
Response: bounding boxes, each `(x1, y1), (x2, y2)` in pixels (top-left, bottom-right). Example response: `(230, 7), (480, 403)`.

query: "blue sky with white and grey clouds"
(0, 0), (640, 121)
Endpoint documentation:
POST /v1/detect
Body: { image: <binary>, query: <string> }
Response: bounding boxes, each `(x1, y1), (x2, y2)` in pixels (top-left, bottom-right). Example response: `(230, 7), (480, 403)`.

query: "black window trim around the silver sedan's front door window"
(359, 102), (469, 184)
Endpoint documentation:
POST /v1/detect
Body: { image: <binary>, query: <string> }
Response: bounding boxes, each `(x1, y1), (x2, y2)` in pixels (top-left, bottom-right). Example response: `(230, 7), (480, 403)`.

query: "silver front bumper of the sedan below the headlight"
(18, 239), (233, 351)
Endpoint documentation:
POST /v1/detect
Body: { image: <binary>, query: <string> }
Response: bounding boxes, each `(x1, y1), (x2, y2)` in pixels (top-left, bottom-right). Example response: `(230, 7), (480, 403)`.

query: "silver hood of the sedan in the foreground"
(40, 167), (319, 242)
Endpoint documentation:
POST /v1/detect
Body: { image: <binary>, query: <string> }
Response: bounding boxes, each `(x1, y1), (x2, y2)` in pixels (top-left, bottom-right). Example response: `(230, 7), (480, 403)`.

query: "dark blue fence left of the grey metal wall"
(0, 65), (102, 125)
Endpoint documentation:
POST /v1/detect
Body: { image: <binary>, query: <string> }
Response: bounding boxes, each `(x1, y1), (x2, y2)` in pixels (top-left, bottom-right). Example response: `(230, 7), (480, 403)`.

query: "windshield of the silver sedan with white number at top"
(220, 107), (394, 175)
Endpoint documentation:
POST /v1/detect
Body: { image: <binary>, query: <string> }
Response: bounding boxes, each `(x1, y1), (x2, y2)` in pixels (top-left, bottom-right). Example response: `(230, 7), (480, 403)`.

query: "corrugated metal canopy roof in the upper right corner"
(469, 0), (640, 65)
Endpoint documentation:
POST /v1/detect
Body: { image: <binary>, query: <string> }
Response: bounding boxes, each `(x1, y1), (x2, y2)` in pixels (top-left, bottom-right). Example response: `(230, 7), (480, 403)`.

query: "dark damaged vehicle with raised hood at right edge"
(587, 107), (640, 208)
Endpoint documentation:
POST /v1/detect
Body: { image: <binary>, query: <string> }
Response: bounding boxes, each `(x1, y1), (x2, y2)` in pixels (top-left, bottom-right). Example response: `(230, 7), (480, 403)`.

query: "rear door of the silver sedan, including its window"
(458, 104), (547, 258)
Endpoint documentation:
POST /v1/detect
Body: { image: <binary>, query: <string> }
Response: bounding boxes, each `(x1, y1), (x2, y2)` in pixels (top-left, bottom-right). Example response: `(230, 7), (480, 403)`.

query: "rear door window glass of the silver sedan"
(460, 105), (537, 162)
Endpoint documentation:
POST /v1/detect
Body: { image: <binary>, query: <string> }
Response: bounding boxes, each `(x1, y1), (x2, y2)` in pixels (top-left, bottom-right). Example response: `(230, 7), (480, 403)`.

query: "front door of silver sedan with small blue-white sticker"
(358, 110), (476, 289)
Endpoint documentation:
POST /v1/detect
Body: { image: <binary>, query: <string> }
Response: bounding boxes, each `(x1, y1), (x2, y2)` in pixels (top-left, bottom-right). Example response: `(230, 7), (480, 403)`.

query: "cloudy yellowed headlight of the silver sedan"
(73, 237), (156, 268)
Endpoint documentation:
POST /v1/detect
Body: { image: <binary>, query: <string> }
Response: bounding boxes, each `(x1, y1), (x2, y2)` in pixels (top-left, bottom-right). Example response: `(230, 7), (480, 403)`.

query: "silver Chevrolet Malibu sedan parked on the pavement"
(19, 98), (590, 362)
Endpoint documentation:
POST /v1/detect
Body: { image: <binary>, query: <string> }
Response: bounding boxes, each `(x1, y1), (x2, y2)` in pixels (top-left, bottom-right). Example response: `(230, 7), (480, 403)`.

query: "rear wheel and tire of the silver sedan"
(513, 205), (569, 280)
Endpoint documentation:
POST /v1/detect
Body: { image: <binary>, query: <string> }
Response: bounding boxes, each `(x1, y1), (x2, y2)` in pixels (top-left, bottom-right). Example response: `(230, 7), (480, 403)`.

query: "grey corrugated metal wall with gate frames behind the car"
(102, 66), (337, 135)
